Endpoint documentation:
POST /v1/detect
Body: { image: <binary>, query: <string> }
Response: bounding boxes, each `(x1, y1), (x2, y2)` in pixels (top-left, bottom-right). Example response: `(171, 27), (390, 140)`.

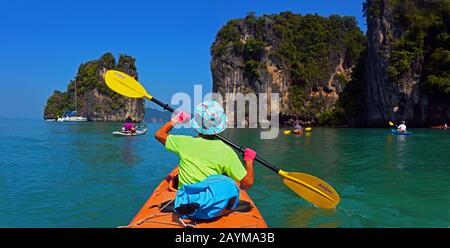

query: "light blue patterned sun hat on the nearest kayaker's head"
(191, 101), (227, 135)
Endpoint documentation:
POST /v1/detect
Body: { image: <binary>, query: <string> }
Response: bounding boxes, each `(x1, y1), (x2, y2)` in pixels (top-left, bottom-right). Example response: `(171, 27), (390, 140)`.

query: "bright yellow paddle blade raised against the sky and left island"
(105, 70), (152, 100)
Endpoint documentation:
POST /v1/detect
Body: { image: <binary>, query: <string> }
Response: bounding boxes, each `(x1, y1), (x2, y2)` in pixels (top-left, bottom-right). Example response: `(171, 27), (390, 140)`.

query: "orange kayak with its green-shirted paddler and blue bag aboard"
(127, 101), (267, 228)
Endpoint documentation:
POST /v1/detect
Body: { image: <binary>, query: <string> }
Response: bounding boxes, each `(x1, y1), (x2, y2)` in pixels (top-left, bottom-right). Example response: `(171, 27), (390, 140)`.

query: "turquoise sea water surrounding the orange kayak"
(0, 120), (450, 227)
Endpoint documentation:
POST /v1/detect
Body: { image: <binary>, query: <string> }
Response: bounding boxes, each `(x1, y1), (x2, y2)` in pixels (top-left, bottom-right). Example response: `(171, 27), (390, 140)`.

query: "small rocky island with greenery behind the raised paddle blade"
(44, 53), (145, 121)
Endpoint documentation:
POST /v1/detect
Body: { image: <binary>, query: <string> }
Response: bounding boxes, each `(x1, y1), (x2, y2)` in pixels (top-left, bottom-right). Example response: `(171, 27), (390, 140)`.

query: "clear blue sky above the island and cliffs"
(0, 0), (366, 118)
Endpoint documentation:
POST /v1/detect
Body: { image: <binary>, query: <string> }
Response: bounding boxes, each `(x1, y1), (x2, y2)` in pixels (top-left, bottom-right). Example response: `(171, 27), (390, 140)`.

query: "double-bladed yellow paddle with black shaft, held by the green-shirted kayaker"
(105, 70), (340, 209)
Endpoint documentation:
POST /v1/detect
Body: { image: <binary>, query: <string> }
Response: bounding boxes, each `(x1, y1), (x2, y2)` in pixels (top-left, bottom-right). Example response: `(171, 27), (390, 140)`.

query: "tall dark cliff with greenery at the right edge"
(363, 0), (450, 126)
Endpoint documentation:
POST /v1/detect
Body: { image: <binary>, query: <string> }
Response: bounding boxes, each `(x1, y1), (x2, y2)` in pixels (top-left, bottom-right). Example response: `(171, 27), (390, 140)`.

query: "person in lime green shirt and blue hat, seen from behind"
(155, 101), (256, 190)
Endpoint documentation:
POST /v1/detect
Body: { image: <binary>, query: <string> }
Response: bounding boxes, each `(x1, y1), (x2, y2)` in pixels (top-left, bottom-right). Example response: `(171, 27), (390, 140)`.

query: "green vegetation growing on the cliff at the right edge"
(364, 0), (450, 95)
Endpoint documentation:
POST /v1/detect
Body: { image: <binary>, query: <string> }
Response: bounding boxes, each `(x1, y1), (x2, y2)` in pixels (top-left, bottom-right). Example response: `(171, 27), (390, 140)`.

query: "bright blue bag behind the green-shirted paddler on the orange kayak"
(175, 175), (239, 220)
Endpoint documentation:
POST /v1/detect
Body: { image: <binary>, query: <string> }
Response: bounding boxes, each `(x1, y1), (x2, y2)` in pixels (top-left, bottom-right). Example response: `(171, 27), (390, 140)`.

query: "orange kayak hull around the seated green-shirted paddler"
(127, 168), (267, 228)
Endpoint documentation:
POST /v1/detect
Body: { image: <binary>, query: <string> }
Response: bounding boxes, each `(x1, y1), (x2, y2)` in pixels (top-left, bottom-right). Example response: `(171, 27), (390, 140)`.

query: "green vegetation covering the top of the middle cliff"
(212, 12), (365, 85)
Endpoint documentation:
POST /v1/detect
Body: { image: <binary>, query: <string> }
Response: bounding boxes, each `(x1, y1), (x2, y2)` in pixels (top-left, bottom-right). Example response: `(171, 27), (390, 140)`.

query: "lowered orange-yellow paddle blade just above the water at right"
(278, 170), (341, 209)
